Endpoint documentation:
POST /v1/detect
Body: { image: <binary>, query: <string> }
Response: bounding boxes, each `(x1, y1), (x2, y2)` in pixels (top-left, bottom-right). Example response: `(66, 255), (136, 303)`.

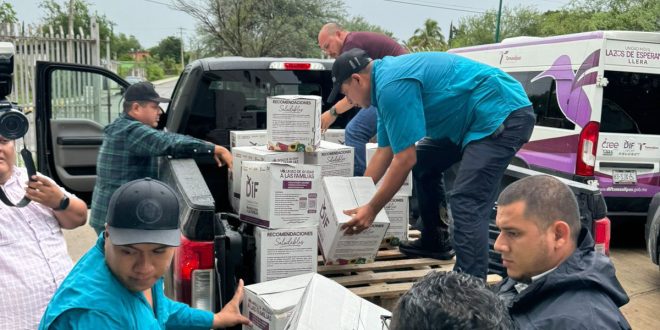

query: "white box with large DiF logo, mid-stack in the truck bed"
(239, 161), (323, 229)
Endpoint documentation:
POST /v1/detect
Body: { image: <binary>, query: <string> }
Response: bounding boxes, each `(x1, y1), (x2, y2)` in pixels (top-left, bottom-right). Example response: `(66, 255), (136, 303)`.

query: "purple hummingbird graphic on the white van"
(531, 50), (600, 127)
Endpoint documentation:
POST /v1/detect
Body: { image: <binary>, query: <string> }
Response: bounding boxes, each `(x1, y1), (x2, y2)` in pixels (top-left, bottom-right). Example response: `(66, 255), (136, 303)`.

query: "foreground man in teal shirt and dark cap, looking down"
(39, 178), (250, 329)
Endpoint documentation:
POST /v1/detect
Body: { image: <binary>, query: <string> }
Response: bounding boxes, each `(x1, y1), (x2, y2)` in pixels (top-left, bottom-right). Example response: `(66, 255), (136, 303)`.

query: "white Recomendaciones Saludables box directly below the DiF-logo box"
(254, 226), (318, 282)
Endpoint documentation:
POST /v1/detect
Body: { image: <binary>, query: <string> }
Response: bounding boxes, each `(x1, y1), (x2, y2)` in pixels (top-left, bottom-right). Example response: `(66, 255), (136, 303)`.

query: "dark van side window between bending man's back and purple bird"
(509, 71), (575, 130)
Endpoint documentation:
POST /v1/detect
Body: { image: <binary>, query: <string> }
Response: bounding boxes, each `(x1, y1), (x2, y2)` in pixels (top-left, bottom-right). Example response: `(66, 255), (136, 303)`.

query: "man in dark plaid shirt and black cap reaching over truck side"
(89, 82), (232, 234)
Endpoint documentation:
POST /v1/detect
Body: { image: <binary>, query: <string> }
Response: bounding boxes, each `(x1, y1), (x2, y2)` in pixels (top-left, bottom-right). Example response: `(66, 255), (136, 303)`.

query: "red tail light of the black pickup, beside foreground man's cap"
(173, 236), (215, 312)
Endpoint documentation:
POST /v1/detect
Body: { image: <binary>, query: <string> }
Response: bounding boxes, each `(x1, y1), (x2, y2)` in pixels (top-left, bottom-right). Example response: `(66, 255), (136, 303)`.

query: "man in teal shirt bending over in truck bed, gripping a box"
(336, 49), (535, 279)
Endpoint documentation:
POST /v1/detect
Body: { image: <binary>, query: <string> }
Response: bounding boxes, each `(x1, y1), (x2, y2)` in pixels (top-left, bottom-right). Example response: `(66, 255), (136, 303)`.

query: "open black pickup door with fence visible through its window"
(34, 62), (129, 203)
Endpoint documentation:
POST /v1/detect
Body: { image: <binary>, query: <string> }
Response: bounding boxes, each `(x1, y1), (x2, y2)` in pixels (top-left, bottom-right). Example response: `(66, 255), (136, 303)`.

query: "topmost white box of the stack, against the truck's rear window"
(266, 95), (321, 152)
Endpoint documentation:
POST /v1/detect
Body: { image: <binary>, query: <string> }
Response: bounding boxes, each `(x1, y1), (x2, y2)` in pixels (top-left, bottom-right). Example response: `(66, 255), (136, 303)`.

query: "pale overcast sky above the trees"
(7, 0), (570, 48)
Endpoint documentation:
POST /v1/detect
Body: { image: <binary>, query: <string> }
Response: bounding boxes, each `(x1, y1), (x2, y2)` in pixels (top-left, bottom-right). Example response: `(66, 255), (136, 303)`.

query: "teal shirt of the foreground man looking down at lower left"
(39, 234), (213, 330)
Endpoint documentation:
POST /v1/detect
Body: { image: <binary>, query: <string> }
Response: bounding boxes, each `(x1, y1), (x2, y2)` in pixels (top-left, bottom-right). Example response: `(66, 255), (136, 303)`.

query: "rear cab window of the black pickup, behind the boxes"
(185, 70), (332, 145)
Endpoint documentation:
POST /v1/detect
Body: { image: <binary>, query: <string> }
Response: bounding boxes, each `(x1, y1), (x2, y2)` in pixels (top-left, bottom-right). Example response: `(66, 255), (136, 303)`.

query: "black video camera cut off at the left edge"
(0, 42), (29, 140)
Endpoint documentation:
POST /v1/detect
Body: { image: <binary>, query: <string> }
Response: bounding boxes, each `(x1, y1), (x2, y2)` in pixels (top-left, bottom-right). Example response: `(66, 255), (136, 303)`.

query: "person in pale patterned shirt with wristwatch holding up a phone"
(0, 135), (87, 329)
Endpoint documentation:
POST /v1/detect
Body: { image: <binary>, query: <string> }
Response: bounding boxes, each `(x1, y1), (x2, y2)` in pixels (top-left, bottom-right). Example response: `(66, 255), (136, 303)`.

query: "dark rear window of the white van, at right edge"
(600, 71), (660, 135)
